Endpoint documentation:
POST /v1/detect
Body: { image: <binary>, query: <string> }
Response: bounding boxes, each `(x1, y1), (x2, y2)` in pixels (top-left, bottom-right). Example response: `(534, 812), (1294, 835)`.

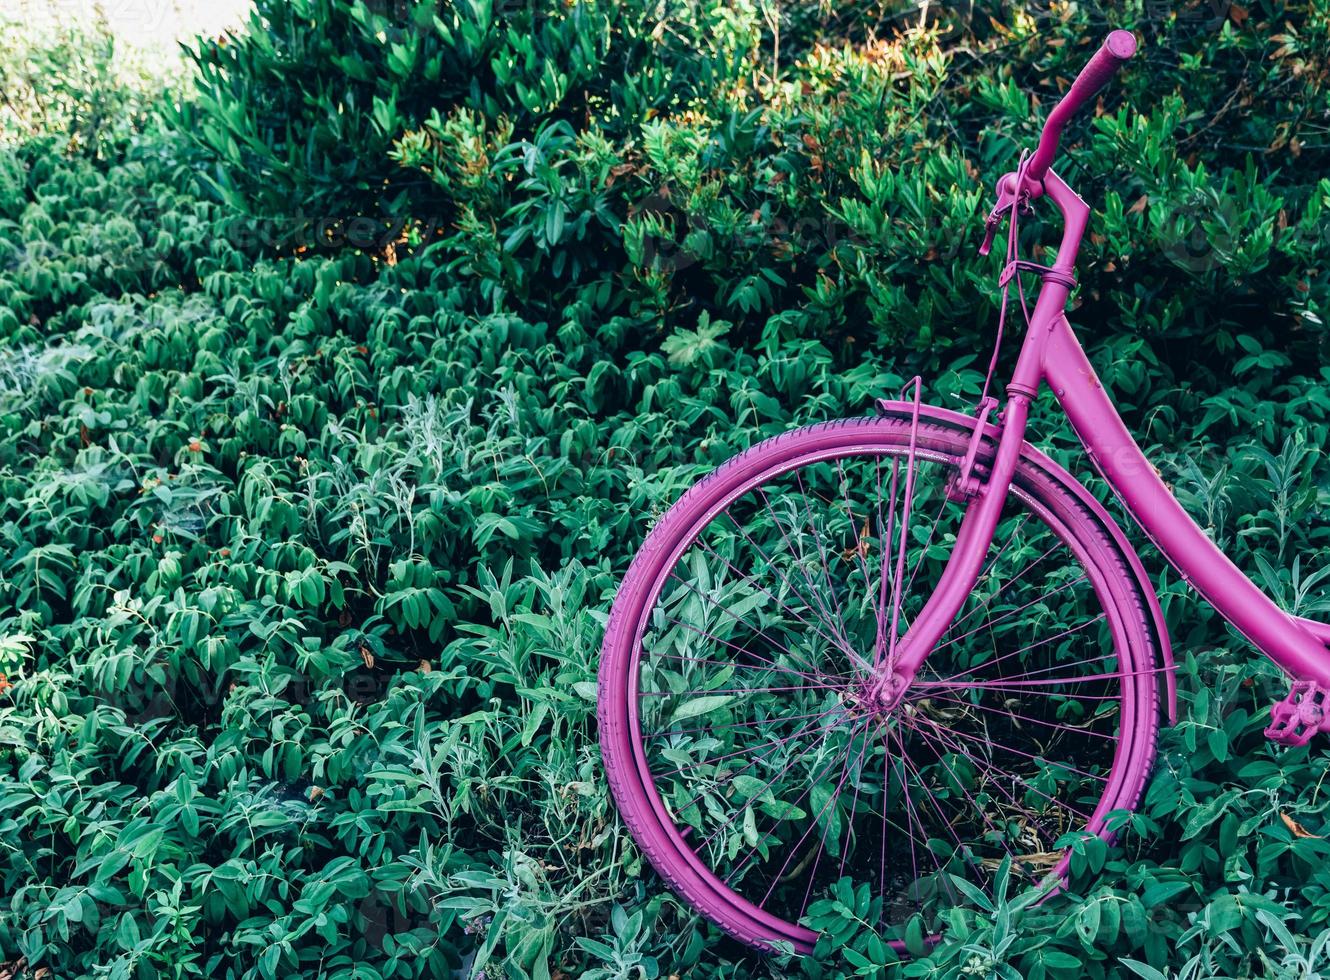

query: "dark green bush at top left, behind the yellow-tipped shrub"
(186, 0), (757, 228)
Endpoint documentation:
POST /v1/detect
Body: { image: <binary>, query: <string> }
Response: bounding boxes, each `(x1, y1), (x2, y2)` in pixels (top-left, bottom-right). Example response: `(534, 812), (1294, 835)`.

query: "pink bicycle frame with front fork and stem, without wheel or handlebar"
(880, 170), (1330, 693)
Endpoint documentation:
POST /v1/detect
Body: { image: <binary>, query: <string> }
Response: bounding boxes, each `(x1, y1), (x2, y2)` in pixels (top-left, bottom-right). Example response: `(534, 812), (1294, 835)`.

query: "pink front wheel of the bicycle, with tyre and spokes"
(599, 418), (1158, 952)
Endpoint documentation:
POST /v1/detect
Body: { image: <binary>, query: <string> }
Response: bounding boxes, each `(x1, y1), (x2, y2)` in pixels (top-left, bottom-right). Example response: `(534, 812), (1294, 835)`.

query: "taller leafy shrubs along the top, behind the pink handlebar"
(184, 3), (1330, 370)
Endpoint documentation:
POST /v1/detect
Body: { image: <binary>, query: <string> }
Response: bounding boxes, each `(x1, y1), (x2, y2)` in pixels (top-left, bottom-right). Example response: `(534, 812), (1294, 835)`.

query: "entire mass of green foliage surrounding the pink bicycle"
(0, 0), (1330, 980)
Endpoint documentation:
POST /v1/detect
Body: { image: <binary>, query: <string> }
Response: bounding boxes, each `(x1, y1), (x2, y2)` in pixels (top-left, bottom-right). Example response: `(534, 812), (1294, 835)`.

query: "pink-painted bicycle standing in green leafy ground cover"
(600, 31), (1330, 953)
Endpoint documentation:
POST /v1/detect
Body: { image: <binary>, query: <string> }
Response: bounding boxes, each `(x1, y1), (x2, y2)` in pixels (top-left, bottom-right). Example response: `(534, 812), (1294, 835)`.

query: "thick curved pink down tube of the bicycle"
(1043, 316), (1330, 686)
